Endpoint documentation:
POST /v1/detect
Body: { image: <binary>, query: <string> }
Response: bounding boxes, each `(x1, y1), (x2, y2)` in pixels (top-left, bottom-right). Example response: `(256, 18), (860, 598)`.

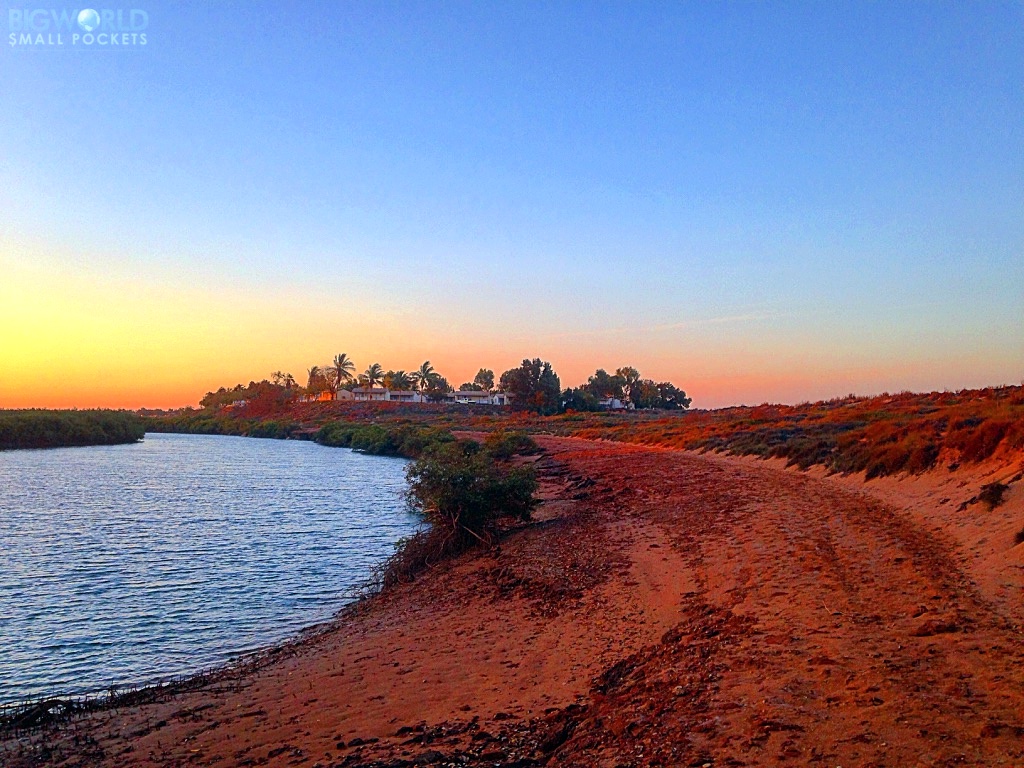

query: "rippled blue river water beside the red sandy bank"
(0, 434), (416, 702)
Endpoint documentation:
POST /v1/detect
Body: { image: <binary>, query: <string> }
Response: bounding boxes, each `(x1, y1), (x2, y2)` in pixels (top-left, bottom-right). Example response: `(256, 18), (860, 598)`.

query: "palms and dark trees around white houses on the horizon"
(200, 352), (690, 415)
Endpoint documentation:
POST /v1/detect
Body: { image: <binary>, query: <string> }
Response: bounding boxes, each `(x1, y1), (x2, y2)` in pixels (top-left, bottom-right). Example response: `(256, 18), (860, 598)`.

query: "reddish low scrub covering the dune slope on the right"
(547, 387), (1024, 479)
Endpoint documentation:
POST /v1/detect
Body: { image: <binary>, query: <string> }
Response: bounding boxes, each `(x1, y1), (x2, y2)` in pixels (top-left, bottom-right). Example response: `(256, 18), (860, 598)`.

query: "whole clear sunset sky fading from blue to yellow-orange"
(0, 0), (1024, 408)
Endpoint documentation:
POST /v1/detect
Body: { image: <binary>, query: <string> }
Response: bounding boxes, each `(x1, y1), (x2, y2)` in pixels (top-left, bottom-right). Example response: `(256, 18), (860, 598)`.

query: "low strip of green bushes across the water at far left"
(0, 410), (145, 451)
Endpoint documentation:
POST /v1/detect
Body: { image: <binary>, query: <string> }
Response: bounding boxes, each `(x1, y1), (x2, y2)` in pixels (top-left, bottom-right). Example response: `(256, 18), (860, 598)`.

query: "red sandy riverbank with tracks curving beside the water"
(8, 437), (1024, 768)
